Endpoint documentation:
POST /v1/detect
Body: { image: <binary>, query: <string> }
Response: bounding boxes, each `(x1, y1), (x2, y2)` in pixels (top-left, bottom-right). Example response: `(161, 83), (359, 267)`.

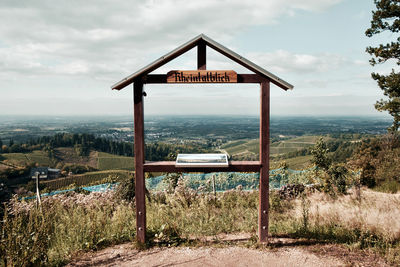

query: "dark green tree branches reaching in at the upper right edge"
(365, 0), (400, 132)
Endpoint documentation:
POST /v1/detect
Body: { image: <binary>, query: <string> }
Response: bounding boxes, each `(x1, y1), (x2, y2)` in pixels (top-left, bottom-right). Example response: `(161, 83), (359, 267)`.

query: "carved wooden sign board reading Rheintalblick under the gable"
(167, 70), (237, 83)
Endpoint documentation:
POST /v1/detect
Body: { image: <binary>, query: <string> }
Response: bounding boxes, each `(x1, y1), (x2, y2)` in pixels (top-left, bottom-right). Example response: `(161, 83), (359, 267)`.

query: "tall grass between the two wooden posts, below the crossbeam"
(147, 182), (258, 238)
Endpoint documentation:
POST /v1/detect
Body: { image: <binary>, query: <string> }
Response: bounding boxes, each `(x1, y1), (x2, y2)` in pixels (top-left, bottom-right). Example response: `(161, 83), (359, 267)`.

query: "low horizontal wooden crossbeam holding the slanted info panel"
(144, 161), (261, 172)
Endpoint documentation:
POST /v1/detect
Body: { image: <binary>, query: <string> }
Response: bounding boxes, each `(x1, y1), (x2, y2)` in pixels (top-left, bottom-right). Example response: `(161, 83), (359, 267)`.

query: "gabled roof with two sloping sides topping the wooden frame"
(111, 34), (293, 90)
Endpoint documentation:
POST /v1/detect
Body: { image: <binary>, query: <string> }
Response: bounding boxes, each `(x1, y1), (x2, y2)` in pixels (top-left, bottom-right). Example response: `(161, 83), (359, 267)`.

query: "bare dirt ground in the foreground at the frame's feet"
(67, 234), (388, 267)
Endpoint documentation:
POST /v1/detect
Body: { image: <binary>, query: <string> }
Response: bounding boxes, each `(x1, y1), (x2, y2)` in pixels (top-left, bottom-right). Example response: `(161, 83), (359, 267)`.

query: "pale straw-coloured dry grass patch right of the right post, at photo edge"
(294, 189), (400, 242)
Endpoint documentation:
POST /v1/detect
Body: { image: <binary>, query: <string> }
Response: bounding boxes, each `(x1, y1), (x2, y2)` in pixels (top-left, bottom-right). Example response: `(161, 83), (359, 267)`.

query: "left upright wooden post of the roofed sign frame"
(133, 79), (146, 244)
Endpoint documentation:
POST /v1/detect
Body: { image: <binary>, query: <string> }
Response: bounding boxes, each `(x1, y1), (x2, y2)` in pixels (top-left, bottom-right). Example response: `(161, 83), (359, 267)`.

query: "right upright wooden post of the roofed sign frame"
(258, 80), (270, 242)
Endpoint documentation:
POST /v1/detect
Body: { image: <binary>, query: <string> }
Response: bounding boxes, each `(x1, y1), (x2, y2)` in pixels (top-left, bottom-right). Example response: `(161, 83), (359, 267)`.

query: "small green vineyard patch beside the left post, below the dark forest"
(97, 152), (134, 171)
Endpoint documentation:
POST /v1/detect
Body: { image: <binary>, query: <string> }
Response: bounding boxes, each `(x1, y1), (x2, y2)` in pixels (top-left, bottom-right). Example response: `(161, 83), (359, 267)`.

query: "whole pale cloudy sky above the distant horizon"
(0, 0), (397, 116)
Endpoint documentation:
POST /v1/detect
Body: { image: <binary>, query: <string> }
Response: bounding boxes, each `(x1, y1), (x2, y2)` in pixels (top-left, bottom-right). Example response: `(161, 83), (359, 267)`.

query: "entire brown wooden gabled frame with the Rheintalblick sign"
(112, 34), (293, 243)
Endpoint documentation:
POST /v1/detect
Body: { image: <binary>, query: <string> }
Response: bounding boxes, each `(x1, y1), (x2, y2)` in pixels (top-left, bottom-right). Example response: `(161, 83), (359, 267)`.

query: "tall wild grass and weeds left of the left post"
(0, 192), (135, 266)
